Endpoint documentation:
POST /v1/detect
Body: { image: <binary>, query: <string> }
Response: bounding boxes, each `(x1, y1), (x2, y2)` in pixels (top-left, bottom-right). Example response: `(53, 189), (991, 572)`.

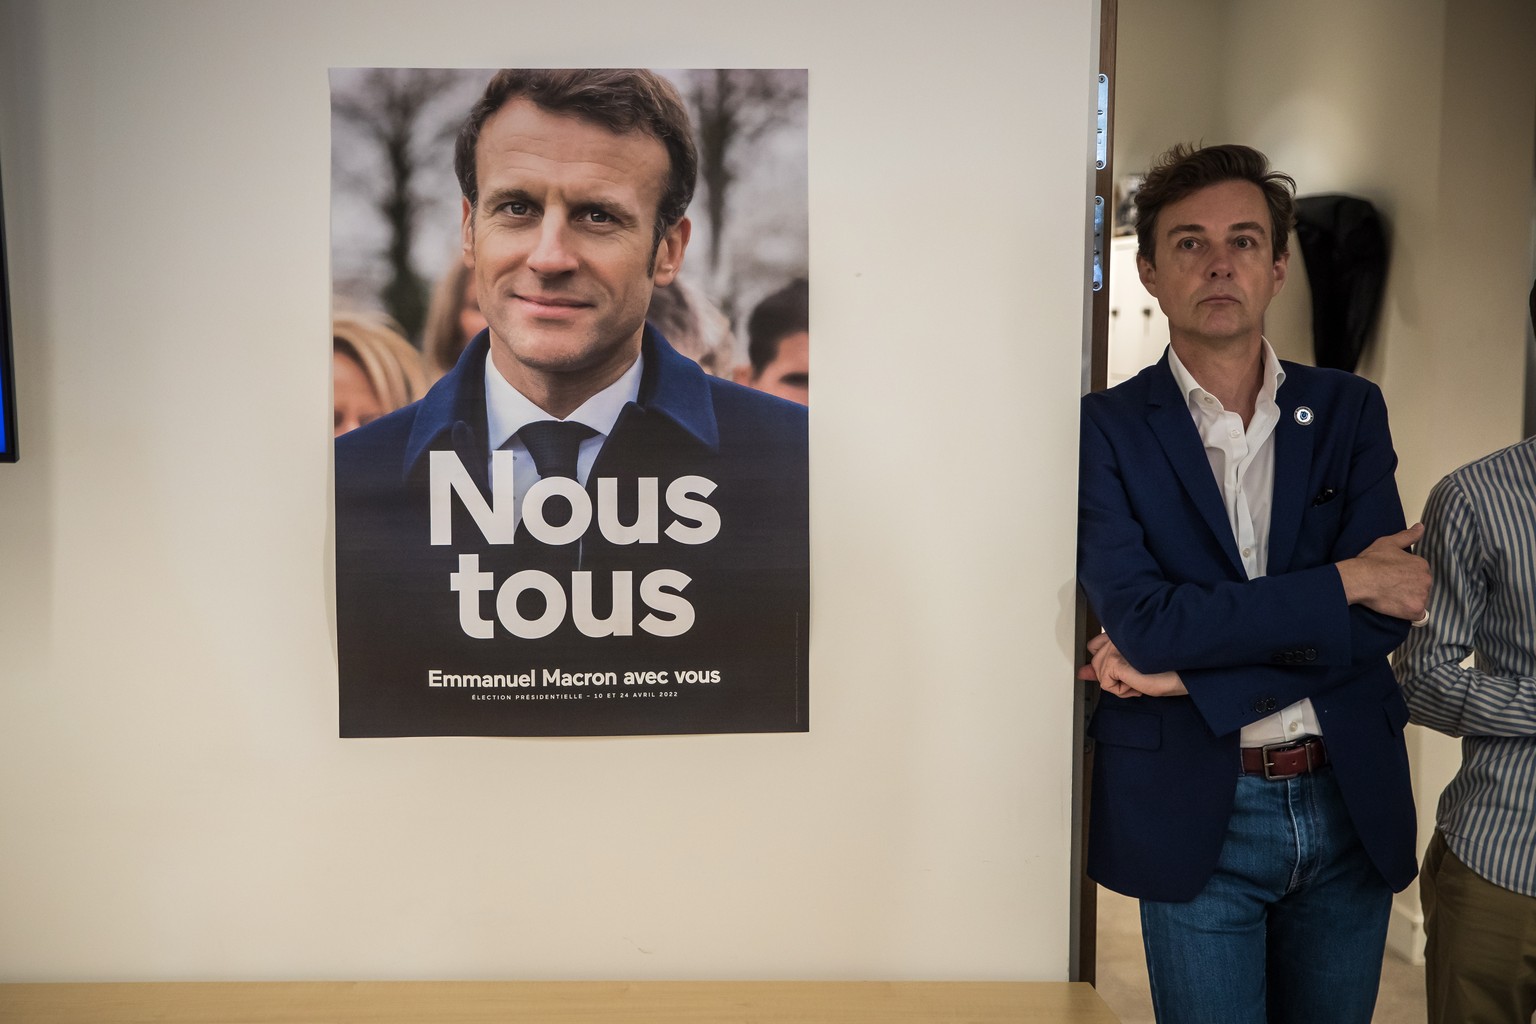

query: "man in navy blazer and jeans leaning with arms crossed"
(1078, 146), (1428, 1024)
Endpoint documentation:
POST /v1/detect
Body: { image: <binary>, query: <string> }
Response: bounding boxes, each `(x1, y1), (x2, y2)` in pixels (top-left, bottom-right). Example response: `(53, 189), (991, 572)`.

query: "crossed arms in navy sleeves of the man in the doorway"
(1078, 388), (1428, 732)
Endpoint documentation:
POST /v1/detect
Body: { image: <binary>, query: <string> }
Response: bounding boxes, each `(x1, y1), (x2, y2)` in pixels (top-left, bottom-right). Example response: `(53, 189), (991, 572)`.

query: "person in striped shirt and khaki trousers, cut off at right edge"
(1396, 438), (1536, 1024)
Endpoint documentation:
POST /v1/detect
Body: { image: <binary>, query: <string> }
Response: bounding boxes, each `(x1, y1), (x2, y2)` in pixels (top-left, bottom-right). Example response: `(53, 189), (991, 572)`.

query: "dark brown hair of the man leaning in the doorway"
(1135, 143), (1296, 267)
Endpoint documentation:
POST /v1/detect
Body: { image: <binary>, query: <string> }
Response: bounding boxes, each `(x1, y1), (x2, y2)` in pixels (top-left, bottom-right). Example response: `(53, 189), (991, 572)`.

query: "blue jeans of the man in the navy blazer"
(1141, 768), (1392, 1024)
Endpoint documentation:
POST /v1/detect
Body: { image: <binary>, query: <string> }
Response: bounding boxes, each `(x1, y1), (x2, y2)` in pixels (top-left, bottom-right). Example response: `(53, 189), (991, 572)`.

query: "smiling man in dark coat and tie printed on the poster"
(336, 71), (809, 735)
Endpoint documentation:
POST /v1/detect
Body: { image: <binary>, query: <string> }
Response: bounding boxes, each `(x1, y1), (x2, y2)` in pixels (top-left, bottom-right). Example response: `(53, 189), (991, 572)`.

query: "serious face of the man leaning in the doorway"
(1137, 181), (1287, 347)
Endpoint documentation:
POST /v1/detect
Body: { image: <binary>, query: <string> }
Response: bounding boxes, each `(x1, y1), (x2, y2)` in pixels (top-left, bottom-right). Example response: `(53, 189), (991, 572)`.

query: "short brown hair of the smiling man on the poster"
(453, 68), (699, 246)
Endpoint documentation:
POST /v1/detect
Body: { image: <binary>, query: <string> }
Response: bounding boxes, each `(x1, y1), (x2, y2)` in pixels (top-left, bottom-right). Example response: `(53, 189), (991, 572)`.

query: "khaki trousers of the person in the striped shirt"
(1419, 831), (1536, 1024)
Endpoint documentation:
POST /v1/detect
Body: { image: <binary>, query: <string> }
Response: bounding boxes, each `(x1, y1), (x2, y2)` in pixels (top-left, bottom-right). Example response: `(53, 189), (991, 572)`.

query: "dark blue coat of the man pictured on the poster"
(335, 327), (809, 737)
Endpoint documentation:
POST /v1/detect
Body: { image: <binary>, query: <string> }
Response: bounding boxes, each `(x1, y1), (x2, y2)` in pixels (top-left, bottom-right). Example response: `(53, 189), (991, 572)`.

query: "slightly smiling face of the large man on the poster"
(462, 98), (690, 416)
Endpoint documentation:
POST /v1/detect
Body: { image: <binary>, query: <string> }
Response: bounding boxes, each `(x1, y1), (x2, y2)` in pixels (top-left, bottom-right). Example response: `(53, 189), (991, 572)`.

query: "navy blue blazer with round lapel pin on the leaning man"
(1078, 355), (1416, 901)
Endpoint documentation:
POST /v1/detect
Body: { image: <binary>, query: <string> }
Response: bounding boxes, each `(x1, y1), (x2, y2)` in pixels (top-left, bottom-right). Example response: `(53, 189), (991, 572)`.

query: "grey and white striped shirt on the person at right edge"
(1395, 438), (1536, 897)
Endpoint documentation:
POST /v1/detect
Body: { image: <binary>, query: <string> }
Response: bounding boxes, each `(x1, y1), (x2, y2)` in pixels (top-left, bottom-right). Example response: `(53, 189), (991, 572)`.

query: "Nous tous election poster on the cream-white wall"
(330, 68), (809, 737)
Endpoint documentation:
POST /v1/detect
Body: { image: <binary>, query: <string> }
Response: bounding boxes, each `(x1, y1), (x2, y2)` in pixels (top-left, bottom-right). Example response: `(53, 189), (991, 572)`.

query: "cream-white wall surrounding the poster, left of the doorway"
(0, 0), (1095, 981)
